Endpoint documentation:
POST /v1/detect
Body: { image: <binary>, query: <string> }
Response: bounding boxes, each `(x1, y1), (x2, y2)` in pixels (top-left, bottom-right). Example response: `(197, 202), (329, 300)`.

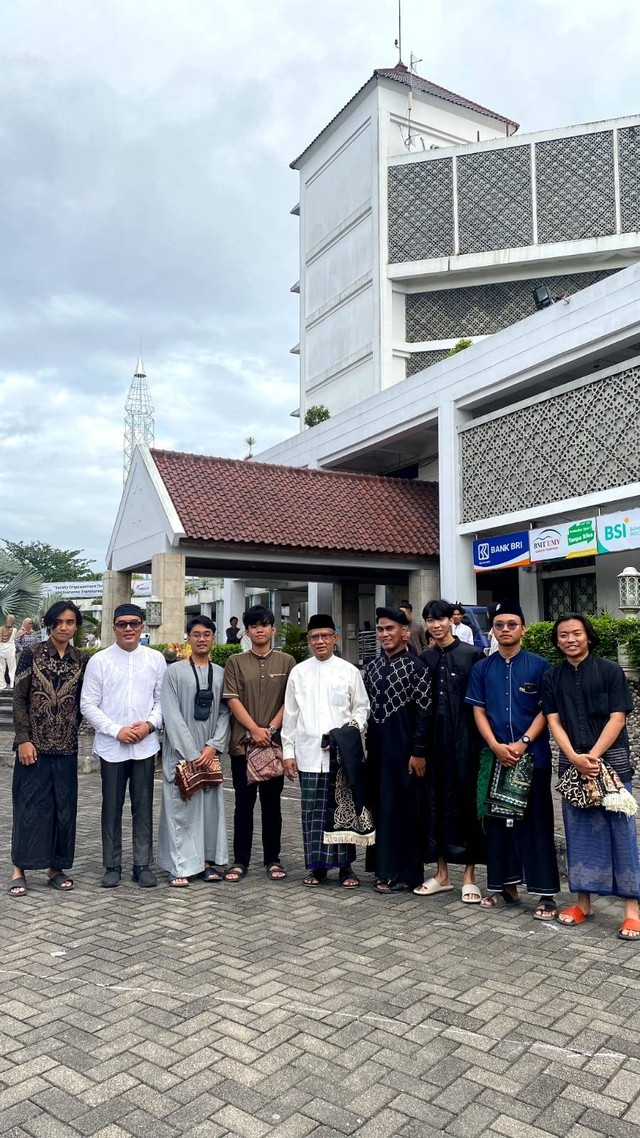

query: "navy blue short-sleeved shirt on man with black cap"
(466, 648), (551, 768)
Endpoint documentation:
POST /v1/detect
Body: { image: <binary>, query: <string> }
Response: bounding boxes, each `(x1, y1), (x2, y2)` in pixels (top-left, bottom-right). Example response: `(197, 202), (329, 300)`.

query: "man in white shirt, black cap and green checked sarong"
(282, 613), (369, 889)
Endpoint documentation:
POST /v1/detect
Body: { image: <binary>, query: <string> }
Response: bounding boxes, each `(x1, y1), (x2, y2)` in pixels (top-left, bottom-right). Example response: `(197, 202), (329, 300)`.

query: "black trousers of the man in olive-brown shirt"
(231, 754), (280, 865)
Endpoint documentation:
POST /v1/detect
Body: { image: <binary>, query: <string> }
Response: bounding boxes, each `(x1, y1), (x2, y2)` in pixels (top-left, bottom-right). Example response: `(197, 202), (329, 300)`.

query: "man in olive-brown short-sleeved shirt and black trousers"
(222, 604), (295, 882)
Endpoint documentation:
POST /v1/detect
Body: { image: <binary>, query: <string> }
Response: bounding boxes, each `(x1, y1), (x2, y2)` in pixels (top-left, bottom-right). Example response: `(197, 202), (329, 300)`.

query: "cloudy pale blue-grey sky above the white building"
(0, 0), (640, 569)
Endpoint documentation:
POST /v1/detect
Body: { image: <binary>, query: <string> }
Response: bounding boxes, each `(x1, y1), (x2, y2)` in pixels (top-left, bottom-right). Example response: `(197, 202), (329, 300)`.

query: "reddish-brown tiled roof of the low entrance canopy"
(150, 450), (438, 558)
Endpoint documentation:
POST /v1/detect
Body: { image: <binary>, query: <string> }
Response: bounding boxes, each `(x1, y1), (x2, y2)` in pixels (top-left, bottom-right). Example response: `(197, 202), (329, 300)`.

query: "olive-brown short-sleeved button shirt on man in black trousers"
(222, 650), (296, 754)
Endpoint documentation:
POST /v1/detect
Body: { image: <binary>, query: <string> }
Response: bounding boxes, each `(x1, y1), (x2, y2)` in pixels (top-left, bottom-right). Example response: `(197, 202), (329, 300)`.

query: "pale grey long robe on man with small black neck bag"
(156, 660), (229, 877)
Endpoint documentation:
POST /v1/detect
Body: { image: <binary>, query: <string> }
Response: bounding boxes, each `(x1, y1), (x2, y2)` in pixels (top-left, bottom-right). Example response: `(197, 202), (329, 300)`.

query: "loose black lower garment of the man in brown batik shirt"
(11, 751), (77, 869)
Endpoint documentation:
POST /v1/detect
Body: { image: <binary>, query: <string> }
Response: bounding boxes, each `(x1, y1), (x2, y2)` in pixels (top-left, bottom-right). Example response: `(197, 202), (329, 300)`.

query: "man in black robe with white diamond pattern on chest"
(364, 608), (430, 893)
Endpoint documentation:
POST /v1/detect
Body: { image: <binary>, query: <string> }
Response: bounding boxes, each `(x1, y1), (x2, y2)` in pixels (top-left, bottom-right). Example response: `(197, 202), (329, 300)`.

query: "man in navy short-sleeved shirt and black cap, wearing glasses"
(466, 601), (560, 921)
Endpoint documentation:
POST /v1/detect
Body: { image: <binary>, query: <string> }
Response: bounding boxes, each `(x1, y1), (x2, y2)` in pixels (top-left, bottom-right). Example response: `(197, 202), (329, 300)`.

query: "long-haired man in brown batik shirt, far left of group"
(7, 601), (87, 897)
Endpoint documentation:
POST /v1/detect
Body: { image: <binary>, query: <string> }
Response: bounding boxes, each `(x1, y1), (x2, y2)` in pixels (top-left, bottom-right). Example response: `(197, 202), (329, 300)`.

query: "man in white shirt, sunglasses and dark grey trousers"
(80, 604), (166, 889)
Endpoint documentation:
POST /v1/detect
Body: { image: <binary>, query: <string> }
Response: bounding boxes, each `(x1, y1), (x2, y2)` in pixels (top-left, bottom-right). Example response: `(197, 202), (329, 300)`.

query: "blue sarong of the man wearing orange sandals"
(563, 782), (640, 900)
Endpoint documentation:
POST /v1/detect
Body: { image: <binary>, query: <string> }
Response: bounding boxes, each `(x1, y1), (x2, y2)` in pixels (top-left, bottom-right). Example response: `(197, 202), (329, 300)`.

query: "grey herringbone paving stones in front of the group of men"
(0, 768), (640, 1138)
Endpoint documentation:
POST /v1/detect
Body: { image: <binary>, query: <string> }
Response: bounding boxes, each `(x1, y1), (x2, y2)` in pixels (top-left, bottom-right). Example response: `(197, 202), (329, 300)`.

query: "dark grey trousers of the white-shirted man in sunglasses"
(100, 754), (156, 867)
